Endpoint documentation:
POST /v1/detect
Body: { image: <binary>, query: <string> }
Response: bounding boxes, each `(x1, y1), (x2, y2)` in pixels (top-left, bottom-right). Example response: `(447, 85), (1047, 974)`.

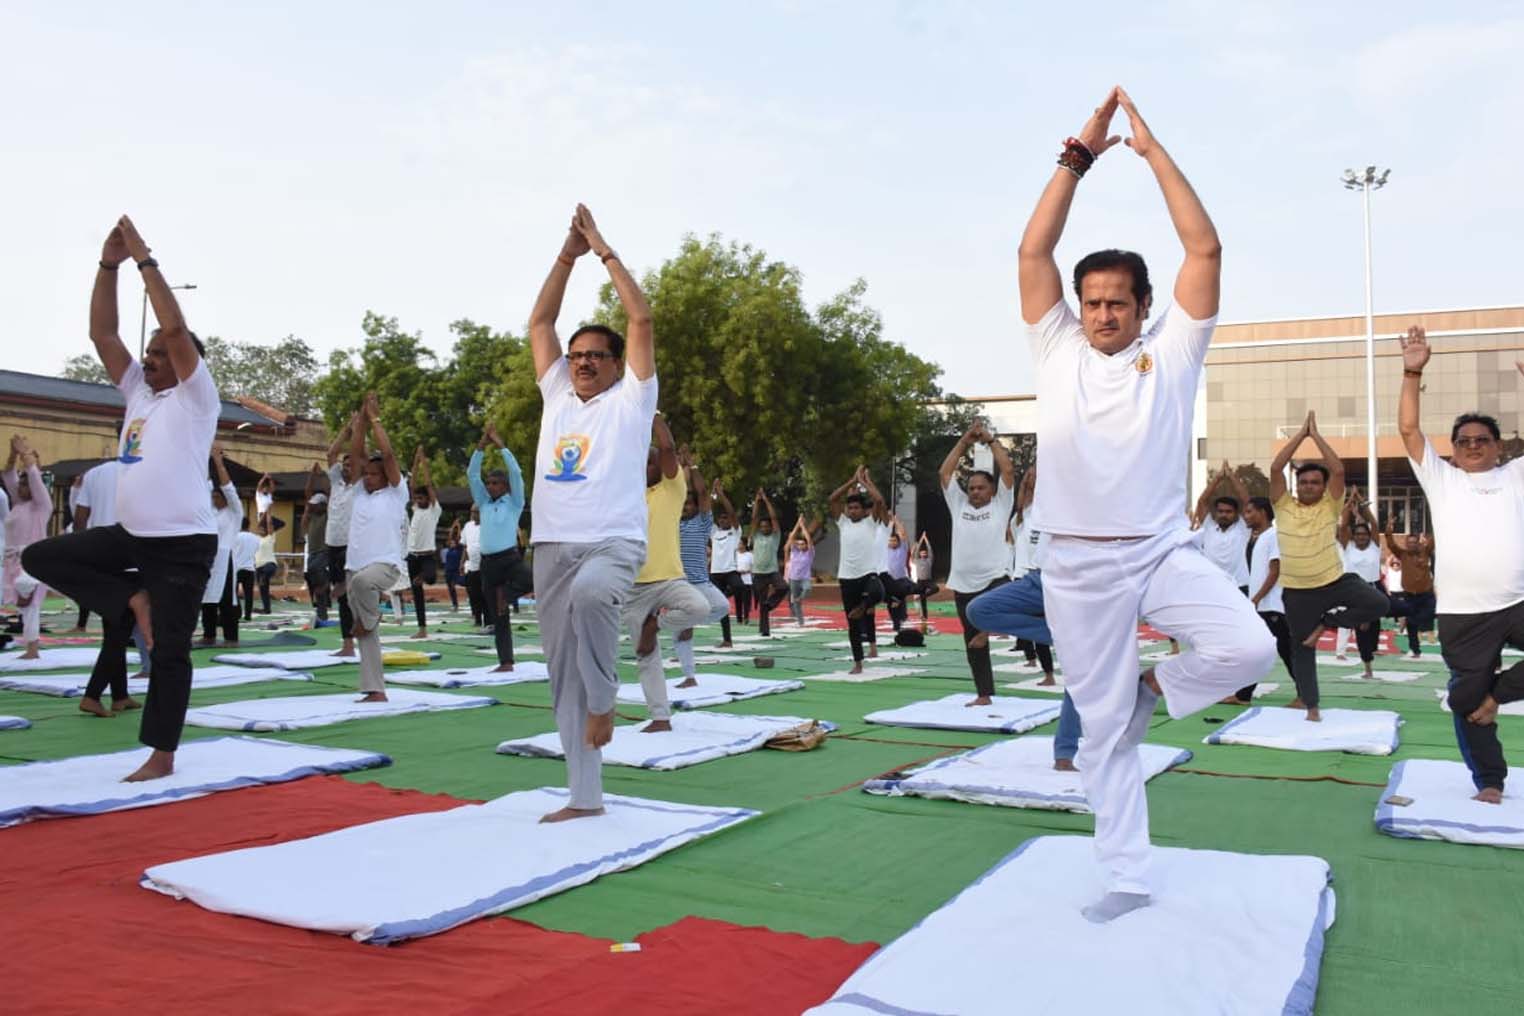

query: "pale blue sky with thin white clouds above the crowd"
(0, 2), (1524, 395)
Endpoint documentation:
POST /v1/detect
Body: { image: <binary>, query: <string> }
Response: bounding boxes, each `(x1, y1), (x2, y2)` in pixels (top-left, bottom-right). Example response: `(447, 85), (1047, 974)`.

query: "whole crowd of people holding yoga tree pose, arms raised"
(3, 88), (1524, 922)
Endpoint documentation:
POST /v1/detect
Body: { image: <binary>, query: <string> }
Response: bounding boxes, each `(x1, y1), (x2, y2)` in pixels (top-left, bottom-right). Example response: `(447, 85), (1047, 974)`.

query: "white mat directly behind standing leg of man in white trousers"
(863, 737), (1190, 815)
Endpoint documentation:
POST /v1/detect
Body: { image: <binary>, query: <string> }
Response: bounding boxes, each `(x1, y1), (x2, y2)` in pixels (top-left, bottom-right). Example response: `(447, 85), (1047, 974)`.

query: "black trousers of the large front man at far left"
(21, 526), (216, 751)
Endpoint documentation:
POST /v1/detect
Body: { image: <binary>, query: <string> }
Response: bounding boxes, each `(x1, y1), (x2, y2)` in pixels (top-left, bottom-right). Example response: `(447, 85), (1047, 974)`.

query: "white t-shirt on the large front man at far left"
(114, 359), (223, 538)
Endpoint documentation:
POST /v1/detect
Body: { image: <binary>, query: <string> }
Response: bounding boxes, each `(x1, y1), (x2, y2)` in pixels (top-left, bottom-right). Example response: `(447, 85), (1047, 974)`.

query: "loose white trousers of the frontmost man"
(1042, 529), (1276, 893)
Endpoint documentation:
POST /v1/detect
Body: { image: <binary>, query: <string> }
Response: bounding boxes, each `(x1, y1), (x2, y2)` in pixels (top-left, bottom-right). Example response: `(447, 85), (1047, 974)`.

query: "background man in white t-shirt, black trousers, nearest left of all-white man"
(937, 422), (1017, 705)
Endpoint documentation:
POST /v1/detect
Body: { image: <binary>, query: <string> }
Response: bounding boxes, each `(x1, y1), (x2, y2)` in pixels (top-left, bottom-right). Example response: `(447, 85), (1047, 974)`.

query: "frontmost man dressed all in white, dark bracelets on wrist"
(1018, 87), (1276, 923)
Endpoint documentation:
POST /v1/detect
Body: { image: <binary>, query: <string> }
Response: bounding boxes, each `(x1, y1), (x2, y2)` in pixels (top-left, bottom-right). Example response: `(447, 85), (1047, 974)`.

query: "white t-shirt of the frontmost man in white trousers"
(1027, 300), (1216, 536)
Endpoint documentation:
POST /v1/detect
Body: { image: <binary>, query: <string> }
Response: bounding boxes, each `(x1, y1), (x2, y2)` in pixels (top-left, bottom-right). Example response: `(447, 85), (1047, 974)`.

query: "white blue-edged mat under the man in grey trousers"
(143, 788), (756, 944)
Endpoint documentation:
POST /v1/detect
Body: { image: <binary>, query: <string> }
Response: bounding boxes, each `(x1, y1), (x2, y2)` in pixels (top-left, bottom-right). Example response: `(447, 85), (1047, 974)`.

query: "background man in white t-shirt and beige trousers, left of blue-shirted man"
(344, 391), (407, 702)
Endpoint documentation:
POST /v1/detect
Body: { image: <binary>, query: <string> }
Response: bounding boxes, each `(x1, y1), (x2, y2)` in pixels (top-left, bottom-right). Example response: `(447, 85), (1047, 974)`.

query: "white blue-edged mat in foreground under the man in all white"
(808, 836), (1335, 1016)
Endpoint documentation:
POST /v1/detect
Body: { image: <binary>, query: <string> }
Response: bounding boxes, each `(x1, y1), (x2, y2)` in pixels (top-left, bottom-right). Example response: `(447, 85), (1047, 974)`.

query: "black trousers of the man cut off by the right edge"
(1438, 603), (1524, 791)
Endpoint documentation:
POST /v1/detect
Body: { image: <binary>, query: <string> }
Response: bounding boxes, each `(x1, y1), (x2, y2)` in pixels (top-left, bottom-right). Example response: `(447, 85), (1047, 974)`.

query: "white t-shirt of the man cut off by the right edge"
(1408, 439), (1524, 614)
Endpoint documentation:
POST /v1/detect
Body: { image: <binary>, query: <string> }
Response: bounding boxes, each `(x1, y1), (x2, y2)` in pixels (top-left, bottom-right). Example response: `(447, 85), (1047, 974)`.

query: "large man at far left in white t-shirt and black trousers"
(23, 215), (223, 781)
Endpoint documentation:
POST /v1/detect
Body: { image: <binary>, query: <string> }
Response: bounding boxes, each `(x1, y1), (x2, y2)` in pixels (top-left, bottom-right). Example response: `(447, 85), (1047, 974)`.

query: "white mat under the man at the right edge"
(1376, 759), (1524, 848)
